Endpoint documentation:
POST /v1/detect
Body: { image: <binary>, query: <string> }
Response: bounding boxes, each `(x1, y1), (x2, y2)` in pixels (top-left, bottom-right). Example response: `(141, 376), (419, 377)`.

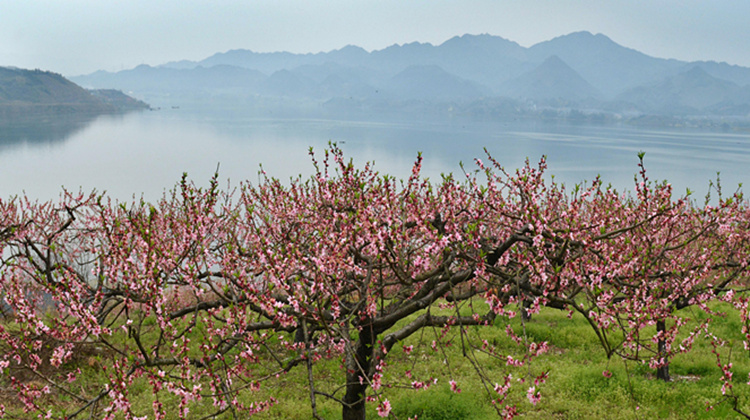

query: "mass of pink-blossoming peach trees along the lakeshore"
(0, 147), (749, 420)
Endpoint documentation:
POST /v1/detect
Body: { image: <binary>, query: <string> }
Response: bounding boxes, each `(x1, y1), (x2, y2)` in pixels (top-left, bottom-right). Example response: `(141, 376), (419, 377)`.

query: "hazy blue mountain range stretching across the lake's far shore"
(71, 32), (750, 117)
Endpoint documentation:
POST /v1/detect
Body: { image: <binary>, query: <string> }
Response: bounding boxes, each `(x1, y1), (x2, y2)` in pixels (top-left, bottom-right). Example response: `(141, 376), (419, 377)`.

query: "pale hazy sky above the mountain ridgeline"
(0, 0), (750, 76)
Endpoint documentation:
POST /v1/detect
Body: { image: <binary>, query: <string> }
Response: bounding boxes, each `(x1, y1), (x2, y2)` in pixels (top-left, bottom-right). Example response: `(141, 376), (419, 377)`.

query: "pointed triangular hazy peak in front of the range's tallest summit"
(499, 55), (601, 101)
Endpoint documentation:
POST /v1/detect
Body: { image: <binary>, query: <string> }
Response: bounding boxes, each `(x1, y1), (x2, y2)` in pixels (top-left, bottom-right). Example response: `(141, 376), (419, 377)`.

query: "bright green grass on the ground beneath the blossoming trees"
(0, 302), (750, 420)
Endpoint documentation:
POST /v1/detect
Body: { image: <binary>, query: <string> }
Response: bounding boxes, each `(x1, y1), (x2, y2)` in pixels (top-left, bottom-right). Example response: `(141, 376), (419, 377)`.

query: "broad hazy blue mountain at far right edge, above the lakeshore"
(618, 66), (750, 115)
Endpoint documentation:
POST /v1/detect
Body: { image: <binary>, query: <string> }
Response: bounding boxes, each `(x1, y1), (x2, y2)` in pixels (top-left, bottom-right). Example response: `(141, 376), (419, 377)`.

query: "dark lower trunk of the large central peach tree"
(342, 323), (377, 420)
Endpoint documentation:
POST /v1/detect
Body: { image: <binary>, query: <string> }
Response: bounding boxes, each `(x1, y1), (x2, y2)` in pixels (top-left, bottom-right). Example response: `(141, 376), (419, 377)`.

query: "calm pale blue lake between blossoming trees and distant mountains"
(0, 108), (750, 200)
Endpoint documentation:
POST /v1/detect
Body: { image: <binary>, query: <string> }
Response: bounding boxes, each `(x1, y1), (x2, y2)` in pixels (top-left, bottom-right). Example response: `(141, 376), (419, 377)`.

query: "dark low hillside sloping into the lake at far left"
(0, 67), (148, 116)
